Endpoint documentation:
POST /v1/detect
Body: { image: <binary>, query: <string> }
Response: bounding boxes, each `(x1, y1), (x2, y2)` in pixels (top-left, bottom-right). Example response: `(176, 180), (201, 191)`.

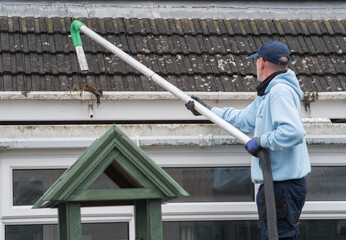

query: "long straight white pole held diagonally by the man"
(80, 26), (250, 144)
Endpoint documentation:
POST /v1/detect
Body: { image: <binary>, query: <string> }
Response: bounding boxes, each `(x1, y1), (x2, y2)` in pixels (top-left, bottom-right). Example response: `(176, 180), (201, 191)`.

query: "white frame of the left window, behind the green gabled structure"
(0, 149), (135, 240)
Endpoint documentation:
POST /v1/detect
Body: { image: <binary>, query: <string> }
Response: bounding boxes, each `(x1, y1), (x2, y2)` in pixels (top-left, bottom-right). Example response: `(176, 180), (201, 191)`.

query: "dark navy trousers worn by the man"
(256, 178), (306, 240)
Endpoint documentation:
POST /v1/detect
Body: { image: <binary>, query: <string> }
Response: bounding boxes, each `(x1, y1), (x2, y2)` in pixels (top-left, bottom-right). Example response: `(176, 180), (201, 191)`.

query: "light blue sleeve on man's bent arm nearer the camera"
(260, 88), (306, 151)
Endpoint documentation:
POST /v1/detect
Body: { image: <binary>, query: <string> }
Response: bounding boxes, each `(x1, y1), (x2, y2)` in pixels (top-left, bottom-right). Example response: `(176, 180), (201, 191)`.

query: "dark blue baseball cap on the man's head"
(248, 41), (290, 66)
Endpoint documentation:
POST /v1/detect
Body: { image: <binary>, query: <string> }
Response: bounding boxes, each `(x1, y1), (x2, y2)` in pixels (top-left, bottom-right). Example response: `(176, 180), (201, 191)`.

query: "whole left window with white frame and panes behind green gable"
(0, 152), (135, 240)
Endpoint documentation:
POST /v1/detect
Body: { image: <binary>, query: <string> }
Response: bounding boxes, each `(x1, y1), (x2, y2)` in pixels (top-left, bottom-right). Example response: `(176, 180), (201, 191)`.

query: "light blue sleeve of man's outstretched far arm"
(213, 98), (258, 132)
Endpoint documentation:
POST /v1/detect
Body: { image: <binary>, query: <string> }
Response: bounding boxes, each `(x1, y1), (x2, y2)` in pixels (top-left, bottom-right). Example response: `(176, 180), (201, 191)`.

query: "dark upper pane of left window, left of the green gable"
(13, 169), (65, 206)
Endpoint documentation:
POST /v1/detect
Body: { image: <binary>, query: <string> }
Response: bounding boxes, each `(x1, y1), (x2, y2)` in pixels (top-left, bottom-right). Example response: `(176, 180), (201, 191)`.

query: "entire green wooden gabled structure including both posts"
(33, 125), (188, 240)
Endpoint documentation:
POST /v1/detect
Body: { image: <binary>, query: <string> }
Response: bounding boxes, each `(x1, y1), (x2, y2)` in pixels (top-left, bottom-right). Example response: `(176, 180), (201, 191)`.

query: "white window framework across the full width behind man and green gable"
(0, 140), (346, 240)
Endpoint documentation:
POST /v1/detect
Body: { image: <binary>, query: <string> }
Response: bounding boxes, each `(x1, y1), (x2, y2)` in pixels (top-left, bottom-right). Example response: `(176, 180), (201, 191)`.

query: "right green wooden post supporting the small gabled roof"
(135, 199), (163, 240)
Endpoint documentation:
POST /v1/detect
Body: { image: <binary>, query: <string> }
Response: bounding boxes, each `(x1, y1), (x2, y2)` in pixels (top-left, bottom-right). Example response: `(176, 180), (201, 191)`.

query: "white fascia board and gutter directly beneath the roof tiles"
(0, 92), (346, 121)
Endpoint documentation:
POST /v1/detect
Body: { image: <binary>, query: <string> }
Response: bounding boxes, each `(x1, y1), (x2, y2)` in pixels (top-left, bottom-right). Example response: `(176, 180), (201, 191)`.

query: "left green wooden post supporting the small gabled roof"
(58, 202), (82, 240)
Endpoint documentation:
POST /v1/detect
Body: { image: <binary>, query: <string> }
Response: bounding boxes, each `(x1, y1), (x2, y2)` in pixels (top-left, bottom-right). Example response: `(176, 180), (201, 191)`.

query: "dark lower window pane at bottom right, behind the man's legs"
(163, 219), (346, 240)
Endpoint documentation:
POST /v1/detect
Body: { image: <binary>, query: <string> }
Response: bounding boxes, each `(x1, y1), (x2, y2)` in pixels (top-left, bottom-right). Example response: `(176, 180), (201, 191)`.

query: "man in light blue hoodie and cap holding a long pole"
(186, 41), (311, 240)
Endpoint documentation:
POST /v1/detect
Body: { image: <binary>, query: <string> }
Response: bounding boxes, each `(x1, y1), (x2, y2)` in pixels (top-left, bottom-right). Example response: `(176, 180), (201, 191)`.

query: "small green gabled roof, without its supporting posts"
(33, 125), (188, 208)
